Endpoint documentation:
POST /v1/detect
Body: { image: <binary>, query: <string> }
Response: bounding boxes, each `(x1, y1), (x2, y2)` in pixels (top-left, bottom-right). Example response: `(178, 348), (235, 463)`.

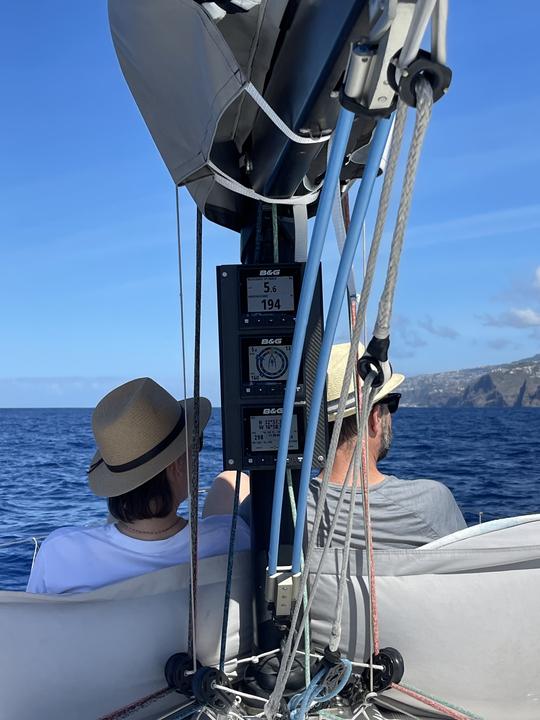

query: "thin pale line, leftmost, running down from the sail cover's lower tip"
(175, 186), (197, 672)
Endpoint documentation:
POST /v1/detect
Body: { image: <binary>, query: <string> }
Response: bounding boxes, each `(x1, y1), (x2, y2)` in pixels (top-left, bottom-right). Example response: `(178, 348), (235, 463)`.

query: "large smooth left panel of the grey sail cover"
(109, 0), (245, 185)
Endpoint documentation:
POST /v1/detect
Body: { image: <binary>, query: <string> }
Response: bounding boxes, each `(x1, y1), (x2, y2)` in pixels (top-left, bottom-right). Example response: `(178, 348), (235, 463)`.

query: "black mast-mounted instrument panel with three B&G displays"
(217, 263), (326, 470)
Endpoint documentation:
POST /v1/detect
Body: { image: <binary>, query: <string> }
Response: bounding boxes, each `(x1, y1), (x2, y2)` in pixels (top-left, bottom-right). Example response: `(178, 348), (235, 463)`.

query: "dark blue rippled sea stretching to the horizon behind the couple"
(0, 408), (540, 590)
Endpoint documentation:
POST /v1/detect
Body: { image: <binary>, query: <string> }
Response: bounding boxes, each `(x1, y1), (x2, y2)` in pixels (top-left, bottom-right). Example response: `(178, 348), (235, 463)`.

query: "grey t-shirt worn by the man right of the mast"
(307, 475), (467, 549)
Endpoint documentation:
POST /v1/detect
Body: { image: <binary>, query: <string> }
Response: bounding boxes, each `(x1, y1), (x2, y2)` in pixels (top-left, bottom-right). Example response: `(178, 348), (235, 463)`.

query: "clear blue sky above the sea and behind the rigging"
(0, 0), (540, 407)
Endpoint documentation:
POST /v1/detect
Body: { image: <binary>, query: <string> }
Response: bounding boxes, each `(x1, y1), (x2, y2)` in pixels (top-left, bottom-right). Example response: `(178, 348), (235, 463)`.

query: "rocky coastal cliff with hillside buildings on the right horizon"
(401, 354), (540, 408)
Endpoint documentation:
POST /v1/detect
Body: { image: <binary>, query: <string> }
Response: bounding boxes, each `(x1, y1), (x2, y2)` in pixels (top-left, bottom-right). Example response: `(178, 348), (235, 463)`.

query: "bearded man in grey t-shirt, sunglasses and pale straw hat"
(308, 343), (467, 548)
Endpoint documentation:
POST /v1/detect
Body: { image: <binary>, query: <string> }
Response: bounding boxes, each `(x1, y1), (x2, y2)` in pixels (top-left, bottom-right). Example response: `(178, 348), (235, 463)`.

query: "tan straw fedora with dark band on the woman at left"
(88, 378), (212, 497)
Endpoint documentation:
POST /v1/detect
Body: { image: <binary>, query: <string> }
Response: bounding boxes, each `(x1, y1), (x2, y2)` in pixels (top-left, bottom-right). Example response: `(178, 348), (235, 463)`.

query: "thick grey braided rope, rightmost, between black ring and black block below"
(373, 77), (433, 338)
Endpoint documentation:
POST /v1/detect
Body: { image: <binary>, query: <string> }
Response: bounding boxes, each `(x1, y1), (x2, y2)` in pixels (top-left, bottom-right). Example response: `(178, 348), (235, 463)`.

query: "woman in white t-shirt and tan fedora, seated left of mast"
(27, 378), (249, 593)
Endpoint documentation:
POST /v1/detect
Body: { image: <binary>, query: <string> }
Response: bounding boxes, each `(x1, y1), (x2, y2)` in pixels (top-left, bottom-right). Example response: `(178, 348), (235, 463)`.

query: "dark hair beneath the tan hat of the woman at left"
(108, 470), (174, 522)
